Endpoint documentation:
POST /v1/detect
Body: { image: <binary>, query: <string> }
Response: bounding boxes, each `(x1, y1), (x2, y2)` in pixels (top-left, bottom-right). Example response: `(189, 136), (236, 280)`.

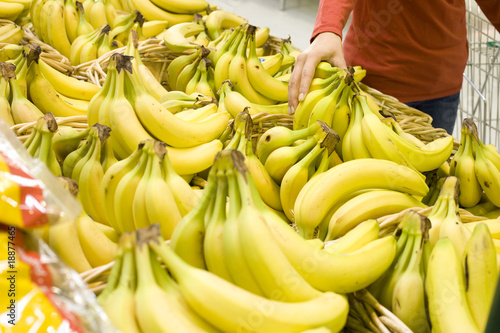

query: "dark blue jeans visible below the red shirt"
(406, 92), (460, 134)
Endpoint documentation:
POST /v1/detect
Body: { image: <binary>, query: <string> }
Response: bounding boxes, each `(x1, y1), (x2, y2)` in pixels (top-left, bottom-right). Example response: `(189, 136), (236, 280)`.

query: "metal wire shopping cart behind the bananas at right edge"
(453, 0), (500, 147)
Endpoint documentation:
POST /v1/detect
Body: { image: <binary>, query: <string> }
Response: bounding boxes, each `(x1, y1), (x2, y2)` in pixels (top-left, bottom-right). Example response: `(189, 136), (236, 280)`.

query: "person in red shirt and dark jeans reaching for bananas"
(288, 0), (500, 134)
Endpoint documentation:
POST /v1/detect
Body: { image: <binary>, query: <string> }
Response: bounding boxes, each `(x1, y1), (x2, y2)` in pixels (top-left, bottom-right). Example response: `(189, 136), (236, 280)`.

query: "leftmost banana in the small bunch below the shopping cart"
(451, 120), (483, 207)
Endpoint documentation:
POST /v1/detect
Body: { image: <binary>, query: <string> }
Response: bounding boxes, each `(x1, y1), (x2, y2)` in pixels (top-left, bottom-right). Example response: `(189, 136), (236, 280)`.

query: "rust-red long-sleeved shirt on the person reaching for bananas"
(313, 0), (500, 102)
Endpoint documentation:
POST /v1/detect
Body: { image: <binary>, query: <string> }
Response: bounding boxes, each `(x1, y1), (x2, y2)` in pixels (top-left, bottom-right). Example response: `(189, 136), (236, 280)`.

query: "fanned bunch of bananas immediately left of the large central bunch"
(97, 137), (198, 239)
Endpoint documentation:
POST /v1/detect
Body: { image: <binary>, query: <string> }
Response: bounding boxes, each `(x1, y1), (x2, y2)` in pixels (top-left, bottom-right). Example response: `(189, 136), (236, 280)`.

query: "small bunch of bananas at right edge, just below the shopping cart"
(450, 118), (500, 210)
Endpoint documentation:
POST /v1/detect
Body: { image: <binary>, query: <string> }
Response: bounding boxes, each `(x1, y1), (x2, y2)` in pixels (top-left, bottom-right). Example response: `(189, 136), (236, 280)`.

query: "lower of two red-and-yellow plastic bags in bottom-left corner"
(0, 225), (117, 333)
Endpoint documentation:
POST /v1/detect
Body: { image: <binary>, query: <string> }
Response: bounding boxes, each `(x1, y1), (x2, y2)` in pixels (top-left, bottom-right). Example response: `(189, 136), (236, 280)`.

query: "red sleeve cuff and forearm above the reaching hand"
(311, 0), (358, 42)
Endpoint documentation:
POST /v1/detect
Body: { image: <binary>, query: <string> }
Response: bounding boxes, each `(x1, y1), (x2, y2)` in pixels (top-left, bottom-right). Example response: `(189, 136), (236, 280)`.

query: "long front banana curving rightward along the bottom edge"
(151, 235), (348, 332)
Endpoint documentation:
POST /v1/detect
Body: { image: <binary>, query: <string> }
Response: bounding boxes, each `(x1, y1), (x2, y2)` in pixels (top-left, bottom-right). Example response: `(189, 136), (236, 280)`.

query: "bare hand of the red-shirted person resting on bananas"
(288, 32), (347, 114)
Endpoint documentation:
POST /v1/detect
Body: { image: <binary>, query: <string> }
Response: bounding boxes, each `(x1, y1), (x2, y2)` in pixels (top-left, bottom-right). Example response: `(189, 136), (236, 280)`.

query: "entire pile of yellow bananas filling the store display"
(0, 0), (500, 333)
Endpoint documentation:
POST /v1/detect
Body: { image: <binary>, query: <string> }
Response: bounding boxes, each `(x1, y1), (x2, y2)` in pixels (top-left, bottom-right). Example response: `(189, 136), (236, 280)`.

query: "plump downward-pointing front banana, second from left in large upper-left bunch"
(107, 53), (153, 158)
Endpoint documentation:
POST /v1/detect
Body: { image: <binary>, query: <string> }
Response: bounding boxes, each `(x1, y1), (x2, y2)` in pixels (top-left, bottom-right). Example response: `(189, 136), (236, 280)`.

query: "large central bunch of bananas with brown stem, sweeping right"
(170, 149), (396, 296)
